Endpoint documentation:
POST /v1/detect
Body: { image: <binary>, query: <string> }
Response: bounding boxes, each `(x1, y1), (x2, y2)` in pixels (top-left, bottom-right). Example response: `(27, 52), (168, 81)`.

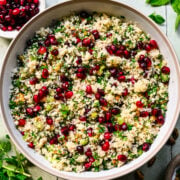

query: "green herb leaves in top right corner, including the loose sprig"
(146, 0), (180, 30)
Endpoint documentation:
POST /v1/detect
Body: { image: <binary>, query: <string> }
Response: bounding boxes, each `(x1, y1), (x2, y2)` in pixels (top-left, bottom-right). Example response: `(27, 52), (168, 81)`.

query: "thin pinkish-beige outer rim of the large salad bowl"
(0, 0), (180, 180)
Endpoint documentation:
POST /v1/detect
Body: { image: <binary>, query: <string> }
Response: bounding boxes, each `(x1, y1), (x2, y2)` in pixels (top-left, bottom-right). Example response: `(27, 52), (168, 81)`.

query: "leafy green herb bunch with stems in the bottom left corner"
(0, 135), (41, 180)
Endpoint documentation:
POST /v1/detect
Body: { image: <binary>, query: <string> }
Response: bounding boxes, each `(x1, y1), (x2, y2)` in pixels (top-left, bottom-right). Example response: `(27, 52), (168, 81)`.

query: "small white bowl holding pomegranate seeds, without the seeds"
(0, 0), (46, 39)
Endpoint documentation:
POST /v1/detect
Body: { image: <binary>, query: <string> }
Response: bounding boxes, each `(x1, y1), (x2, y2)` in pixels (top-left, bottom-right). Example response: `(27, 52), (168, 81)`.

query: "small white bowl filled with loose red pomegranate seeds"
(0, 0), (45, 39)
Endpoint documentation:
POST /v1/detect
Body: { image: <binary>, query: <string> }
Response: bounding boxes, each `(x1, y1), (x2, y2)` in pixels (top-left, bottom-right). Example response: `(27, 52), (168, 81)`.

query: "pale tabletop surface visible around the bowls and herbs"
(0, 0), (180, 180)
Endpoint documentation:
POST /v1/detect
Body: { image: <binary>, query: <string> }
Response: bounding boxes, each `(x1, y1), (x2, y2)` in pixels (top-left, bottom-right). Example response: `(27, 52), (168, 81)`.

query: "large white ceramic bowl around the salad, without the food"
(0, 0), (180, 180)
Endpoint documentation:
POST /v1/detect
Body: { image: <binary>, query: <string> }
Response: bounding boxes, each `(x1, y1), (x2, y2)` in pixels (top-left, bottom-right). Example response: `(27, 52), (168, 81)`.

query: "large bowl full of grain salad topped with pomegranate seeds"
(0, 0), (180, 179)
